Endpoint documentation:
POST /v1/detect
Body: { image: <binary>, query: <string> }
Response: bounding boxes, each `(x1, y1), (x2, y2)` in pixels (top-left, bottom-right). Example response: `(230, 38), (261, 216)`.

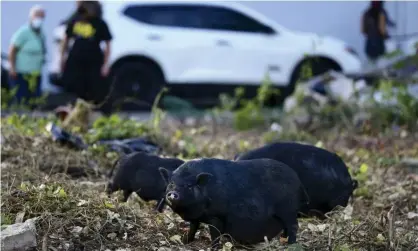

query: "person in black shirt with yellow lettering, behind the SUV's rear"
(61, 1), (112, 103)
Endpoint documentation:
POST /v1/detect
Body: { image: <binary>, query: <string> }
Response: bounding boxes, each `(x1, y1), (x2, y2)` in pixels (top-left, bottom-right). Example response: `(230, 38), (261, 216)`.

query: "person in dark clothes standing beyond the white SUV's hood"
(361, 1), (389, 62)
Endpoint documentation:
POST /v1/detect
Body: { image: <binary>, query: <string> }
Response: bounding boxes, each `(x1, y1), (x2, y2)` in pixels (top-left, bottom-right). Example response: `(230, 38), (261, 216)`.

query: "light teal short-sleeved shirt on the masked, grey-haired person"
(11, 24), (45, 73)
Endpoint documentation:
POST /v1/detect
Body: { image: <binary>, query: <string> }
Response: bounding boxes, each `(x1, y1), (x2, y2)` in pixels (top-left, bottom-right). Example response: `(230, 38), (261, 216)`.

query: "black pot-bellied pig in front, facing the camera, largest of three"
(160, 158), (308, 248)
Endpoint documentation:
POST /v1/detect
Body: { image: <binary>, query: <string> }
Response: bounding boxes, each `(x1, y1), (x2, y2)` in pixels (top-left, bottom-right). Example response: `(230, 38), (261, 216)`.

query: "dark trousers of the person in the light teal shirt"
(9, 73), (42, 107)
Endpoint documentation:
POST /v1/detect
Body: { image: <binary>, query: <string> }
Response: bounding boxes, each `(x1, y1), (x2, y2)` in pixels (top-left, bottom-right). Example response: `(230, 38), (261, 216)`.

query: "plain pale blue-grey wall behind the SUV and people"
(1, 1), (418, 89)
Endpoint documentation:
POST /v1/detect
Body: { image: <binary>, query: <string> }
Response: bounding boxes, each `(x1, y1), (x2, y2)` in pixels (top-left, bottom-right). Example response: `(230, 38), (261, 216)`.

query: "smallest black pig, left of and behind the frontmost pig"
(106, 152), (184, 212)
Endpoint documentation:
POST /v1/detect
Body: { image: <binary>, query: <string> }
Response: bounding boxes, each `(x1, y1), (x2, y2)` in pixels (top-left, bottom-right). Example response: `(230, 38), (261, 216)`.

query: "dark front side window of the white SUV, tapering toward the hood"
(201, 6), (266, 33)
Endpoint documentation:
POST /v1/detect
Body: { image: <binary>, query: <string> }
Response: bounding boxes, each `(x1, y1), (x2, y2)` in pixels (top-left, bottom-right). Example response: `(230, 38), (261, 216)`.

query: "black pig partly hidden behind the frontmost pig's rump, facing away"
(235, 142), (357, 218)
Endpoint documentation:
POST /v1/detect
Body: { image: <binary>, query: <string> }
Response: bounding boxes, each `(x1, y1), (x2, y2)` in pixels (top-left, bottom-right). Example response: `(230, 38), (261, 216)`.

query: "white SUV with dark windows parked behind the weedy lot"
(50, 1), (361, 108)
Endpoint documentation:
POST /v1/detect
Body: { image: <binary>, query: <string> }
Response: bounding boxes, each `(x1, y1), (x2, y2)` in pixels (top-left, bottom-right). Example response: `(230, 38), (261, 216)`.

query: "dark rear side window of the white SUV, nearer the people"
(124, 5), (203, 28)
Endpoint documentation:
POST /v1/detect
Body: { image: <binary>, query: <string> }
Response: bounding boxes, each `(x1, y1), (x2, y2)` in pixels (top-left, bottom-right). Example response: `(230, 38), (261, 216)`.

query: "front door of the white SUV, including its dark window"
(196, 6), (288, 85)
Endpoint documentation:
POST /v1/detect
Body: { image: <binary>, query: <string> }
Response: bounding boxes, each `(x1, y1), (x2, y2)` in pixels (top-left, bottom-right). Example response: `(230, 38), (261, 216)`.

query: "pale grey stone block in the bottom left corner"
(1, 219), (36, 251)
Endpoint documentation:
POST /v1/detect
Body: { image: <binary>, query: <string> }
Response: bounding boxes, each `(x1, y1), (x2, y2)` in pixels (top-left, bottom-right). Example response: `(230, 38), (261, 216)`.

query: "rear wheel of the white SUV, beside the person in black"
(104, 61), (165, 110)
